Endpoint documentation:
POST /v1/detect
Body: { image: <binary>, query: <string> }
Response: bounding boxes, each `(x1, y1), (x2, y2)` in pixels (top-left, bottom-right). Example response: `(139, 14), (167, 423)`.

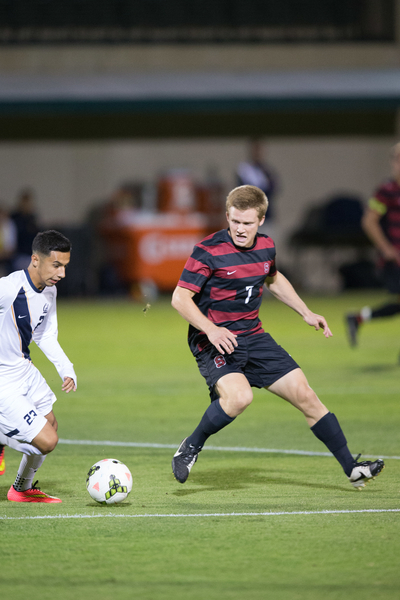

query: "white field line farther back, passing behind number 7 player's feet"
(58, 439), (400, 460)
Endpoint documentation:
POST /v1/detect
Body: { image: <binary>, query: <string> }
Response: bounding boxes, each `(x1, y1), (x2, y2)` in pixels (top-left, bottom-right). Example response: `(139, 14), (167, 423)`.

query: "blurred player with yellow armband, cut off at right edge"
(346, 143), (400, 346)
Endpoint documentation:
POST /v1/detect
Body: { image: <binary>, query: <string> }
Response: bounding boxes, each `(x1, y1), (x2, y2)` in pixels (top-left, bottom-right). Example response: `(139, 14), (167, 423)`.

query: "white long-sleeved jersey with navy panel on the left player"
(0, 270), (76, 386)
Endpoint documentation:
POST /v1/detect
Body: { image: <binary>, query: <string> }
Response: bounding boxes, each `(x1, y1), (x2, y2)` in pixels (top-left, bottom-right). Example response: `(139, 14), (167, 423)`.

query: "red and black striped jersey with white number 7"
(178, 229), (276, 353)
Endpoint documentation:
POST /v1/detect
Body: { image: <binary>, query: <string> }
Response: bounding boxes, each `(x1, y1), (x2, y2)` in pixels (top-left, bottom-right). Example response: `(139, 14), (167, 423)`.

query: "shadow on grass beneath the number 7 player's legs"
(173, 468), (355, 497)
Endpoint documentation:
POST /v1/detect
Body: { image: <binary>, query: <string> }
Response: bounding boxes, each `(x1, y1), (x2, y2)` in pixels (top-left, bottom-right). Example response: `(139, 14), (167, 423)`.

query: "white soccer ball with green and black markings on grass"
(86, 458), (132, 504)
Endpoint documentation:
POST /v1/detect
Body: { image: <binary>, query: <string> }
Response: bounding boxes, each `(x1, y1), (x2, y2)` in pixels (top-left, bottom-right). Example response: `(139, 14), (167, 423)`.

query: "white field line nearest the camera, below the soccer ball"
(0, 508), (400, 521)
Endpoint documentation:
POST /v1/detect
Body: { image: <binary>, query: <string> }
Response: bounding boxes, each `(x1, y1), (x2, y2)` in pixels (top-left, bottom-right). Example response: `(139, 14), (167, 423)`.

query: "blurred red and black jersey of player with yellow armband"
(370, 180), (400, 250)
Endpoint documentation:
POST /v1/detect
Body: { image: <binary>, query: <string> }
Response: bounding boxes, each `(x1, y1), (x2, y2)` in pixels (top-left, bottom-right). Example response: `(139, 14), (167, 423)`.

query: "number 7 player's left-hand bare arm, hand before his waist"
(171, 286), (237, 354)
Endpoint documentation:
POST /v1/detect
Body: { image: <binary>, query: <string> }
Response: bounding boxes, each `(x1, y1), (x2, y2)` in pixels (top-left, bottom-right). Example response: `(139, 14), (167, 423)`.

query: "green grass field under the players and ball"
(0, 292), (400, 600)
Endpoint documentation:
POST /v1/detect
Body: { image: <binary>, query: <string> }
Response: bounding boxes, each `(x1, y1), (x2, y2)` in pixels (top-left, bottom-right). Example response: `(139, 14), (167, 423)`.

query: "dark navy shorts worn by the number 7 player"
(196, 332), (299, 401)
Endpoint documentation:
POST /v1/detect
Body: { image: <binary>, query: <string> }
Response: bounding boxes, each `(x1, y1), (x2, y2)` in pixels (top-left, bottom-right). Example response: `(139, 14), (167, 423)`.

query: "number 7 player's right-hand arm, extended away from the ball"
(265, 271), (332, 338)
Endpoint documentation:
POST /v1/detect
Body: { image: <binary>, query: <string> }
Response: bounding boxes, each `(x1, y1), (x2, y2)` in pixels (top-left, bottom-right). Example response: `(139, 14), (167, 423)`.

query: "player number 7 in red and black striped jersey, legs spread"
(172, 185), (384, 489)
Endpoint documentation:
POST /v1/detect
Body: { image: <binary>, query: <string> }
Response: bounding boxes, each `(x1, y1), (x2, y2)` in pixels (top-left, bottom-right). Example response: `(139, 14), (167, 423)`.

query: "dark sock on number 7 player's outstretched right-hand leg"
(311, 412), (354, 477)
